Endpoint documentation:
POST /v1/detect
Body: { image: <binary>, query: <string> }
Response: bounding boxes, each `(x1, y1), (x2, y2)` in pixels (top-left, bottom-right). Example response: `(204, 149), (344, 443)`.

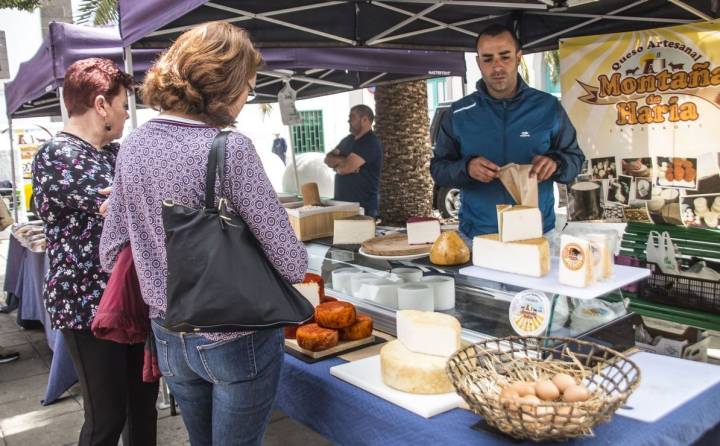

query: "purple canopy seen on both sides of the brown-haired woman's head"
(5, 22), (465, 114)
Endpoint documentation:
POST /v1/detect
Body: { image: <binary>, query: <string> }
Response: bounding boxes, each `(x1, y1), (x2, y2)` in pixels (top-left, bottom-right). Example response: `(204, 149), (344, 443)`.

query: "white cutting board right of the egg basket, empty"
(615, 352), (720, 423)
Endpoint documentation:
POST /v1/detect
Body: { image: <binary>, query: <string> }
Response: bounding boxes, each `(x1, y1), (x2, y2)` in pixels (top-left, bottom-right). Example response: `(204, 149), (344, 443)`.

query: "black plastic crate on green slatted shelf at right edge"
(639, 262), (720, 314)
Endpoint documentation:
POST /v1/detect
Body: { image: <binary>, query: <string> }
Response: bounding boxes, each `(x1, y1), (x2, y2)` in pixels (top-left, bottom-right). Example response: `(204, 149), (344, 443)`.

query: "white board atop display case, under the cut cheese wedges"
(460, 257), (650, 299)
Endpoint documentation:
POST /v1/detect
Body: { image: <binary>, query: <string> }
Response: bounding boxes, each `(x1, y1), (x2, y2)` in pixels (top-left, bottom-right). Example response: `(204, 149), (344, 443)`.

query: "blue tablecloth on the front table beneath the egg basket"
(277, 354), (720, 446)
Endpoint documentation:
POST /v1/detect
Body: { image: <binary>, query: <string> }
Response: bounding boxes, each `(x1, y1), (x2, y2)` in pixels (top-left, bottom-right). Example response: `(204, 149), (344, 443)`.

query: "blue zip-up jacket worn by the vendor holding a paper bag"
(430, 76), (585, 237)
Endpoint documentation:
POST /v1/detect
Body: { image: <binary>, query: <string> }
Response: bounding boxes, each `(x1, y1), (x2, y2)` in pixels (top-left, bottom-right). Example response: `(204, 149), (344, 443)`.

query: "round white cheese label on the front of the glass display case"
(508, 290), (550, 336)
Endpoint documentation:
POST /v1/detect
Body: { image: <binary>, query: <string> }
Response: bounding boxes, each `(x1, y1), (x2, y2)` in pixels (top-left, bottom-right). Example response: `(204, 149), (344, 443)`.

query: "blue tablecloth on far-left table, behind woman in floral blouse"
(4, 236), (77, 406)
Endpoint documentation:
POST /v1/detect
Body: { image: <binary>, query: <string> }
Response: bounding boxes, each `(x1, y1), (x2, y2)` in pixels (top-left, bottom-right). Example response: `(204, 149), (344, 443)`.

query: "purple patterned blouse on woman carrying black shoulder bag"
(100, 116), (308, 339)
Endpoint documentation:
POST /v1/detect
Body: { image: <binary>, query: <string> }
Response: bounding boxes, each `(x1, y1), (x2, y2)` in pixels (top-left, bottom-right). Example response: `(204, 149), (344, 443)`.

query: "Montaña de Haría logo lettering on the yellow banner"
(576, 39), (720, 126)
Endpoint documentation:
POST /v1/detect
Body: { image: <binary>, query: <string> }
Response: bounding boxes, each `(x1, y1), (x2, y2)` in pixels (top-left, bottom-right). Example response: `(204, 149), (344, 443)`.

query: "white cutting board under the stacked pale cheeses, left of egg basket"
(330, 355), (462, 418)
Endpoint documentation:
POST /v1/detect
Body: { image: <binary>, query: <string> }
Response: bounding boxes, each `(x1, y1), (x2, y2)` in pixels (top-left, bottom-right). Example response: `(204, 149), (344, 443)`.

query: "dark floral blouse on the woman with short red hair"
(32, 132), (119, 330)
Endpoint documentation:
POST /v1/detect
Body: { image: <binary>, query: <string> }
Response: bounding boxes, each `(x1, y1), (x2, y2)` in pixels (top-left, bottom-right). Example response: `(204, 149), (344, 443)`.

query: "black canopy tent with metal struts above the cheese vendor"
(119, 0), (720, 53)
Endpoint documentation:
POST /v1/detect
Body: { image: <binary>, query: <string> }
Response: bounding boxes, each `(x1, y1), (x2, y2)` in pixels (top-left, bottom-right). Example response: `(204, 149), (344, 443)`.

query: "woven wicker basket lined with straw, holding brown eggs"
(447, 336), (640, 441)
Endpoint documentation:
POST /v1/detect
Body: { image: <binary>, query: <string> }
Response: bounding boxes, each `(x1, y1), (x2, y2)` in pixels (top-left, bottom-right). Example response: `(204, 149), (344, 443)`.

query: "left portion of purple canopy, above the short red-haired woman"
(5, 22), (158, 118)
